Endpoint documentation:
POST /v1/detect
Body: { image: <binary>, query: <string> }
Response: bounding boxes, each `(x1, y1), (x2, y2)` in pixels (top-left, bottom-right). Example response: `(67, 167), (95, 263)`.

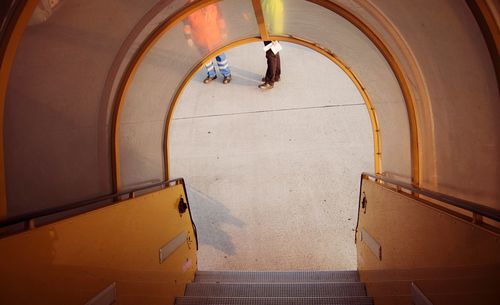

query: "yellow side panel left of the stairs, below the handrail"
(0, 185), (196, 304)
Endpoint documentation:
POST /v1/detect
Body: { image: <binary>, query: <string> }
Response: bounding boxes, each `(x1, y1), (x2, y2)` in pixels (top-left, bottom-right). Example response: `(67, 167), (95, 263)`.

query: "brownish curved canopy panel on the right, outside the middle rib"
(337, 0), (500, 208)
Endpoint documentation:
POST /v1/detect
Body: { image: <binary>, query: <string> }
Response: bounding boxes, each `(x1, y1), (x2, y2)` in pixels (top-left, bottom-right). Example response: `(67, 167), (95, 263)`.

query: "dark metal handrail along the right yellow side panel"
(360, 172), (500, 222)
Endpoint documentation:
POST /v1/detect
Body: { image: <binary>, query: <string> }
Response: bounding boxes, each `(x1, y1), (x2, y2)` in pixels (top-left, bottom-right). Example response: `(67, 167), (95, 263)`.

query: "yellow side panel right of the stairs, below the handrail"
(357, 180), (500, 305)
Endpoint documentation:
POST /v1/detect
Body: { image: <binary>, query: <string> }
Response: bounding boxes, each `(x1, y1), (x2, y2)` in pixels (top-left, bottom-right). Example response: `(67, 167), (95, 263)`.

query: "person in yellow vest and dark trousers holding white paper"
(259, 0), (283, 89)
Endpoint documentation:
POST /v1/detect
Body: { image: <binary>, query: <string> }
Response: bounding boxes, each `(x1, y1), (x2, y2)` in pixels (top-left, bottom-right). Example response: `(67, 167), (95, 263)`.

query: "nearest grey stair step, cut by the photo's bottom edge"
(175, 297), (373, 305)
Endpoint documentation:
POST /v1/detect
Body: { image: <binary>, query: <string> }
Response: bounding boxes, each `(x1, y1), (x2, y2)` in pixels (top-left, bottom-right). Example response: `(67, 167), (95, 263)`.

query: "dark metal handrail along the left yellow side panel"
(0, 178), (184, 228)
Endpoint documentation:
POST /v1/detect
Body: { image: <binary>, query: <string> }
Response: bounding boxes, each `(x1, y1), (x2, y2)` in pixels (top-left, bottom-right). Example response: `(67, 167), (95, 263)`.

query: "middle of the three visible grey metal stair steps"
(184, 283), (366, 297)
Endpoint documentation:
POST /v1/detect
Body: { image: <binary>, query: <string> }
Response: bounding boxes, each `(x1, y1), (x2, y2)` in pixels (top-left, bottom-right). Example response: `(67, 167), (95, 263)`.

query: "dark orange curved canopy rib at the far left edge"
(0, 0), (38, 218)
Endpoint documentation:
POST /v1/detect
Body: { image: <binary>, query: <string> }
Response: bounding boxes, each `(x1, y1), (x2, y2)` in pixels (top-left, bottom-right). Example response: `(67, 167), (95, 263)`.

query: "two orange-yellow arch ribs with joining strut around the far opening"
(113, 0), (412, 185)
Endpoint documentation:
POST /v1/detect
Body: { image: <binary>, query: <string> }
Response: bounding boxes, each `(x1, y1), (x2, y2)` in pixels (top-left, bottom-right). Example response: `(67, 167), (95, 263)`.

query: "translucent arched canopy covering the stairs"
(4, 0), (500, 214)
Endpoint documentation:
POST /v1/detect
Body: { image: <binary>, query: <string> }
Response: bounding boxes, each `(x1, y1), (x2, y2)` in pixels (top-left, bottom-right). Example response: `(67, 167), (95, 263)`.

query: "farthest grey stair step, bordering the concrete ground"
(195, 271), (359, 283)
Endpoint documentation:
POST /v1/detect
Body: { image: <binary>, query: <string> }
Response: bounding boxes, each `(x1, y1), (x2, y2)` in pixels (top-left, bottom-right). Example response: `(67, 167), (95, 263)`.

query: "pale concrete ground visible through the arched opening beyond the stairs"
(170, 43), (374, 270)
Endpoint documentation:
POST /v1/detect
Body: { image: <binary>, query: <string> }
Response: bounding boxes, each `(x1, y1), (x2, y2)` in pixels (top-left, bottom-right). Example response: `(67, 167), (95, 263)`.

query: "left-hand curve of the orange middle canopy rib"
(111, 0), (223, 191)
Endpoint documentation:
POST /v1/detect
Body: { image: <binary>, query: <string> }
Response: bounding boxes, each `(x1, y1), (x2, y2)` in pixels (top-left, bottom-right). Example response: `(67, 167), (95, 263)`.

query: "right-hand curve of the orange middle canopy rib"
(305, 0), (420, 186)
